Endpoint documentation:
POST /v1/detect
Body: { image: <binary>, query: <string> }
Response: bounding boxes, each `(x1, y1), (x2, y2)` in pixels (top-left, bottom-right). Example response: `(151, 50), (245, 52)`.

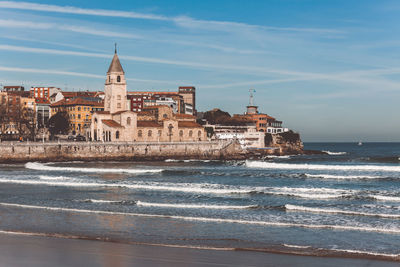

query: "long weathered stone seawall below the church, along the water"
(0, 141), (246, 163)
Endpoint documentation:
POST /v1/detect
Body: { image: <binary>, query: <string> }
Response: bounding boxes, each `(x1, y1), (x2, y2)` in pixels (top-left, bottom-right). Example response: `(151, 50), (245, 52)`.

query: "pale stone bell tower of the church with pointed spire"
(104, 46), (127, 114)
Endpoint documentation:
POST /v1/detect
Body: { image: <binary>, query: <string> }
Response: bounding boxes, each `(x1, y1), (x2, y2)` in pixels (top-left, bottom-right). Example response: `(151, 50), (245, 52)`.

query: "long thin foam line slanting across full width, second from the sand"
(0, 203), (400, 234)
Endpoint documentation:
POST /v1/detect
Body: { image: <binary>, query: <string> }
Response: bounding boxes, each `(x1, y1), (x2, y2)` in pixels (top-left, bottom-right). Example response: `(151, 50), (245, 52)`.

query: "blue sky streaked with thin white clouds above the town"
(0, 0), (400, 142)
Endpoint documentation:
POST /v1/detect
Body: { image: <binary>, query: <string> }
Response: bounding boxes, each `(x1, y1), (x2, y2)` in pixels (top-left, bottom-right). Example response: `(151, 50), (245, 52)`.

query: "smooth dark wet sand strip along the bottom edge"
(0, 234), (399, 267)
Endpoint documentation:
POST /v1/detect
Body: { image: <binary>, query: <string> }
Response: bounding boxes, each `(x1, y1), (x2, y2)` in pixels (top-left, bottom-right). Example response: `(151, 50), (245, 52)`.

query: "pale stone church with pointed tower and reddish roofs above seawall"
(90, 50), (207, 142)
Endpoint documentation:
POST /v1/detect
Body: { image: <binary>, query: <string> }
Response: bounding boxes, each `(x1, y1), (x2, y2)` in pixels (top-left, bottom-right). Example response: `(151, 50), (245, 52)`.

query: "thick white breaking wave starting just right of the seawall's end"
(246, 160), (400, 172)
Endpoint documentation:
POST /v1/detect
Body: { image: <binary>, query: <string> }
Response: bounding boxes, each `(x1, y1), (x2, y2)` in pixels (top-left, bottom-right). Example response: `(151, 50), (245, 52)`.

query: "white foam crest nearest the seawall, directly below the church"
(25, 162), (163, 174)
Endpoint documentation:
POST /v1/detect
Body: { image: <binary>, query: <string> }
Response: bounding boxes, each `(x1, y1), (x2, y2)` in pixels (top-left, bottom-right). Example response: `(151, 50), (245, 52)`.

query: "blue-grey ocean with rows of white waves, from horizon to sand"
(0, 143), (400, 260)
